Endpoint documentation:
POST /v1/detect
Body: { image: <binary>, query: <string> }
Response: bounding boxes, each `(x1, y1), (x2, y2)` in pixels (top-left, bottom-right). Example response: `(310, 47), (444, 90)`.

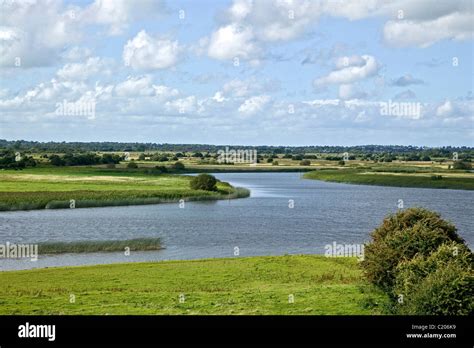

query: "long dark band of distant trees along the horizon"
(0, 139), (474, 157)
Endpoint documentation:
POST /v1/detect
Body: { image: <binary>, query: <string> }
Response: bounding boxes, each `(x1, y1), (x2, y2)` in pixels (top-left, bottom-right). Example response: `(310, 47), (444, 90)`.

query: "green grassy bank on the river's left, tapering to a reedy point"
(0, 167), (249, 211)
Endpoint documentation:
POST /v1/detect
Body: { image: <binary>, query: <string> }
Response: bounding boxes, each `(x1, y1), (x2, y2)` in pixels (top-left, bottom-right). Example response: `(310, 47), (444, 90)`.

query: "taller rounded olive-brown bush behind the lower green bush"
(361, 208), (464, 294)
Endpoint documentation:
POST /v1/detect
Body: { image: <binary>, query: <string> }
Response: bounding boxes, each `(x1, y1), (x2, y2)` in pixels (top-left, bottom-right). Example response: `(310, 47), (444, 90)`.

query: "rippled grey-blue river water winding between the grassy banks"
(0, 173), (474, 270)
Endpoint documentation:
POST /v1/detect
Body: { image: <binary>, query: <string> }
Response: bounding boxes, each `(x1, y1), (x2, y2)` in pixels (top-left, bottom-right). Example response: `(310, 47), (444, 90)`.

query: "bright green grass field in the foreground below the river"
(0, 255), (386, 315)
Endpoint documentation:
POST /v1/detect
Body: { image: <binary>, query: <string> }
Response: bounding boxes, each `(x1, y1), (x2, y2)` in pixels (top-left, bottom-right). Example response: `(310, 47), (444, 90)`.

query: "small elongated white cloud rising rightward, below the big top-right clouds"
(314, 55), (379, 87)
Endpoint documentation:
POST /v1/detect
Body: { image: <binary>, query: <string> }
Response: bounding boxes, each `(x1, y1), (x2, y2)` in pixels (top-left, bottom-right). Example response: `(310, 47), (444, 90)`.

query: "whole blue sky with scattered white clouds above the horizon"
(0, 0), (474, 146)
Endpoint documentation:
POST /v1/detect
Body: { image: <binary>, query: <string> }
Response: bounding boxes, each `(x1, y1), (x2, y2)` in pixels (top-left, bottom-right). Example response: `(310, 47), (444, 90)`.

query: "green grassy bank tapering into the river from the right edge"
(303, 169), (474, 190)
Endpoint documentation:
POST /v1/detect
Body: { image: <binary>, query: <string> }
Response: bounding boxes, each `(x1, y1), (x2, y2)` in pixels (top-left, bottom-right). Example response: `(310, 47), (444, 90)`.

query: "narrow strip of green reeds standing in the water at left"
(38, 238), (162, 254)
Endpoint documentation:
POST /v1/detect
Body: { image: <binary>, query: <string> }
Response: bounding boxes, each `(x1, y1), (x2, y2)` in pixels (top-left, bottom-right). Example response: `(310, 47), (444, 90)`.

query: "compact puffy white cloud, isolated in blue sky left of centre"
(122, 30), (182, 70)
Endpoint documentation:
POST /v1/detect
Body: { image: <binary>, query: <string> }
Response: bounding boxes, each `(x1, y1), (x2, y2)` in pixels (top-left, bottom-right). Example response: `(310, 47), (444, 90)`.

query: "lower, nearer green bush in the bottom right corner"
(394, 242), (474, 315)
